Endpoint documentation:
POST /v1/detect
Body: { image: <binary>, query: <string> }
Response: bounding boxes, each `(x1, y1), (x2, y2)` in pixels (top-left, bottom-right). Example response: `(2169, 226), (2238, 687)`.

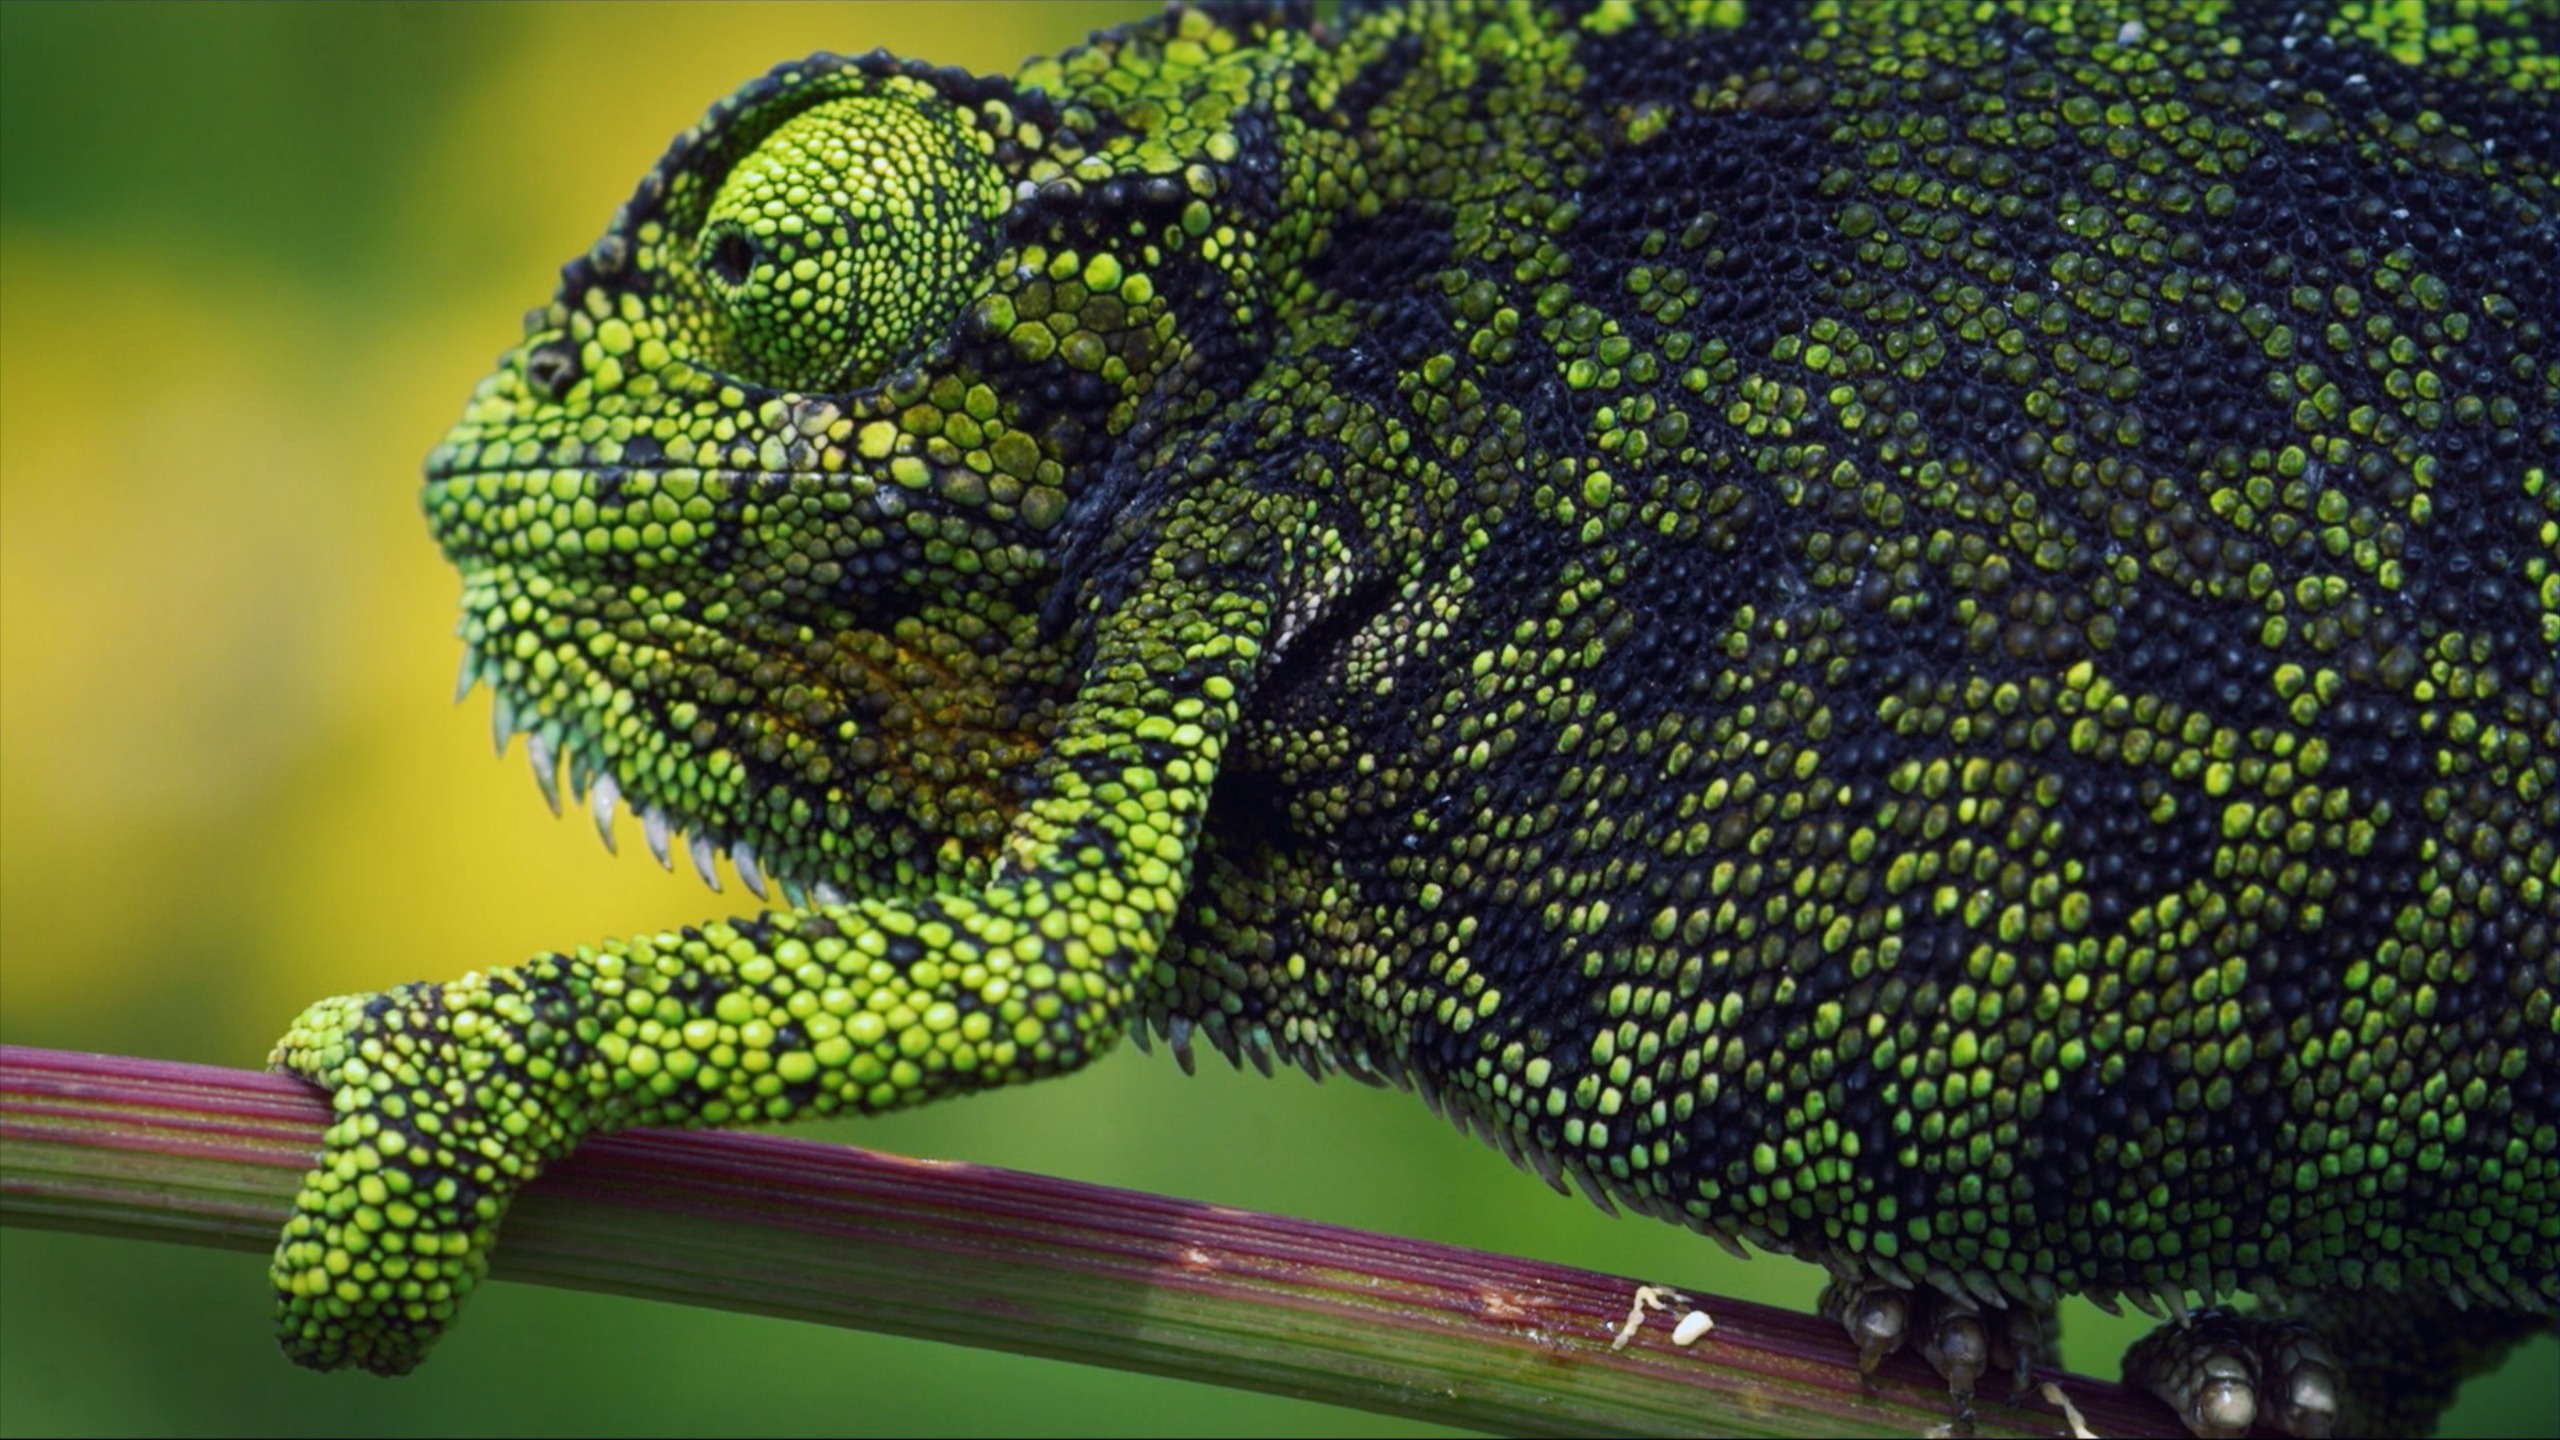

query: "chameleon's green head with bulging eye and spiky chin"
(425, 33), (1290, 894)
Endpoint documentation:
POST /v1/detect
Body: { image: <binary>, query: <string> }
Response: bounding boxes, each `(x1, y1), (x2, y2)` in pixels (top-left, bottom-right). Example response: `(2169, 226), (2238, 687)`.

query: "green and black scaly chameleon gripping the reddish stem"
(274, 0), (2560, 1435)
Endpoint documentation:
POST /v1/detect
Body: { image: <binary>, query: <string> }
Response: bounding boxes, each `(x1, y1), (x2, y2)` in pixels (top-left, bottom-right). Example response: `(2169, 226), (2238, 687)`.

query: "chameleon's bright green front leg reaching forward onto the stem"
(271, 568), (1270, 1376)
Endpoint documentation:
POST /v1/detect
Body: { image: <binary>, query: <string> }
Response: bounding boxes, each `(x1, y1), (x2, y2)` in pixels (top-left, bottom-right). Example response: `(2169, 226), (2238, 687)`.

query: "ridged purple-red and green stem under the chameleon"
(0, 1045), (2173, 1435)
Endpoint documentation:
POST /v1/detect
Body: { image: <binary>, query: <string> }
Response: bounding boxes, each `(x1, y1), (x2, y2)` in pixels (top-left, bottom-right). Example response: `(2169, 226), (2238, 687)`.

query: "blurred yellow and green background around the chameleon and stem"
(0, 3), (2560, 1435)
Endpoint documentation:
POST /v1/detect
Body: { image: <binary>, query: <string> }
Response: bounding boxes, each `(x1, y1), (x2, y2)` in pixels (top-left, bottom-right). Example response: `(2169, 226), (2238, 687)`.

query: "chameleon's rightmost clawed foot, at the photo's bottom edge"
(2125, 1309), (2340, 1440)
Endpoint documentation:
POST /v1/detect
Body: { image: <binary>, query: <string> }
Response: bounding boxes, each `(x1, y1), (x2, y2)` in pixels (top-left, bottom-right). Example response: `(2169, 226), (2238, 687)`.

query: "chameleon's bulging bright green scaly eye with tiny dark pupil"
(694, 95), (1001, 389)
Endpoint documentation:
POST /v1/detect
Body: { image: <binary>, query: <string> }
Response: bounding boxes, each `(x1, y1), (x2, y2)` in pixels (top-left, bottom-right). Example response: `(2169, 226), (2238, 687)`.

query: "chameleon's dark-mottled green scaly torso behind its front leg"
(1155, 5), (2560, 1314)
